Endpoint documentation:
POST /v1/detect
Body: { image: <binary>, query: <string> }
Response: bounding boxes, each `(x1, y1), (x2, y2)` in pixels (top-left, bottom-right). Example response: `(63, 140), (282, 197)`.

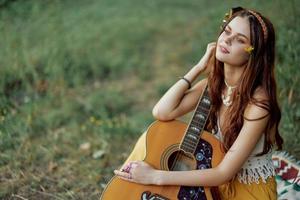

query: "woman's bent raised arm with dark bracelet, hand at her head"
(152, 42), (215, 121)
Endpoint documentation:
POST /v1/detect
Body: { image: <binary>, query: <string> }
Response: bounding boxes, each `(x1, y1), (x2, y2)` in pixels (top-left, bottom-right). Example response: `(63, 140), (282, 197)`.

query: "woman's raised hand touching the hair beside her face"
(196, 42), (216, 73)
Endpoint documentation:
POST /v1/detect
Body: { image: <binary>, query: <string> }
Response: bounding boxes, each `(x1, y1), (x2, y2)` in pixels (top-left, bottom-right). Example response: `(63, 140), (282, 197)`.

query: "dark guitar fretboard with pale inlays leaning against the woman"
(180, 86), (211, 154)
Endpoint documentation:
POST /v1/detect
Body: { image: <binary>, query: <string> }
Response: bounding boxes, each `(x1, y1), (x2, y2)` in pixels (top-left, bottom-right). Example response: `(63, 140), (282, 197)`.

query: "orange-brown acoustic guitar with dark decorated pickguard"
(100, 87), (224, 200)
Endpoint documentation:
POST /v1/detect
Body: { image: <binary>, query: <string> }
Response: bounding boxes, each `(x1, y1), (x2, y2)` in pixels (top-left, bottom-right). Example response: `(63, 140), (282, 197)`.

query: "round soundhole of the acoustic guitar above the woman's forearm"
(168, 150), (196, 171)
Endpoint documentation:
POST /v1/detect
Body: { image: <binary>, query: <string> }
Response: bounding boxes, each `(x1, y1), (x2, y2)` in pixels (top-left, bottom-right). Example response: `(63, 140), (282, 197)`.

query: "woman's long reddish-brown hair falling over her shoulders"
(208, 9), (283, 155)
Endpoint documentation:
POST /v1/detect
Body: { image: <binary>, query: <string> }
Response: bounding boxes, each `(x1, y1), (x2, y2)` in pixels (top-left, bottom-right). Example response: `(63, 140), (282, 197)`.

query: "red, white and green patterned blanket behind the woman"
(272, 152), (300, 200)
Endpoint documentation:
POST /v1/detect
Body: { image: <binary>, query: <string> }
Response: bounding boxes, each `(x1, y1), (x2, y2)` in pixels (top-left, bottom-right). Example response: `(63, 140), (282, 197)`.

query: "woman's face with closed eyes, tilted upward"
(216, 16), (251, 66)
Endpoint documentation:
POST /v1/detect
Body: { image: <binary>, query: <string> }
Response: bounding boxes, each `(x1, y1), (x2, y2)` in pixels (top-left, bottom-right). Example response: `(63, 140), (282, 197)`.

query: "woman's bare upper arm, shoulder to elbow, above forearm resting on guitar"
(218, 88), (269, 182)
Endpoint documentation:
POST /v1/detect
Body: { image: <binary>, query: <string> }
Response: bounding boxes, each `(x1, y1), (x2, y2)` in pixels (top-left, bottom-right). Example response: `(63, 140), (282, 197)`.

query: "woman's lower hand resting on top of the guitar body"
(114, 161), (157, 185)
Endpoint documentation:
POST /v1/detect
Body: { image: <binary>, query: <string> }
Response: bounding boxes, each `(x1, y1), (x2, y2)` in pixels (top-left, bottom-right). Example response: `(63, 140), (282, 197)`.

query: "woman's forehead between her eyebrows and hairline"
(228, 16), (250, 38)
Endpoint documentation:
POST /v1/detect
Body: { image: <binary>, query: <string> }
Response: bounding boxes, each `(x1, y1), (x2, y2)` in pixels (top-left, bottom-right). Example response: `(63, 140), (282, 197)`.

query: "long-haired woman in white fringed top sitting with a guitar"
(115, 7), (283, 200)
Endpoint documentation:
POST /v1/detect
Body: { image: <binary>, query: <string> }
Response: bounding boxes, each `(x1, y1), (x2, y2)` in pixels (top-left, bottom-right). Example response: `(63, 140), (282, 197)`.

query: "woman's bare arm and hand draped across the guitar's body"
(115, 90), (269, 186)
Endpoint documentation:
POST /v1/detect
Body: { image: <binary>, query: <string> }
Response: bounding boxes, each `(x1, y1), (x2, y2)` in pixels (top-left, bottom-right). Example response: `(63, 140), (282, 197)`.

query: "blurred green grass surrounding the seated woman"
(0, 0), (300, 199)
